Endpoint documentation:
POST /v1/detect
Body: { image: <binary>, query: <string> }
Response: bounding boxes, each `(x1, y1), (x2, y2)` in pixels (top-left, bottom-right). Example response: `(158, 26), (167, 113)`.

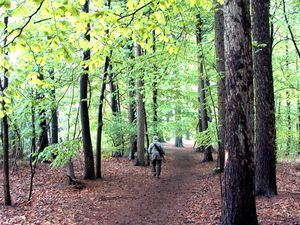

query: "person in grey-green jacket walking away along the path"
(148, 136), (165, 178)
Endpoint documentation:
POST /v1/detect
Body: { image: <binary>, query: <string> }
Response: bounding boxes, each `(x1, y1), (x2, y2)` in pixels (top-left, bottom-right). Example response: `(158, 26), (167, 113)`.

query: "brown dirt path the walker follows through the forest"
(89, 144), (217, 225)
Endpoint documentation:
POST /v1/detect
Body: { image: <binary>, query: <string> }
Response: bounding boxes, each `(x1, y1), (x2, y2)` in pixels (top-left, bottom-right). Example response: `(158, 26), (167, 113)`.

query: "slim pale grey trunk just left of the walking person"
(135, 43), (145, 166)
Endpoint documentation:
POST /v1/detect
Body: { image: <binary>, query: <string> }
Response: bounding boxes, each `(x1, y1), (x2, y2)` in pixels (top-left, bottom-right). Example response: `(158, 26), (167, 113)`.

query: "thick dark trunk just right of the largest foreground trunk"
(252, 0), (277, 195)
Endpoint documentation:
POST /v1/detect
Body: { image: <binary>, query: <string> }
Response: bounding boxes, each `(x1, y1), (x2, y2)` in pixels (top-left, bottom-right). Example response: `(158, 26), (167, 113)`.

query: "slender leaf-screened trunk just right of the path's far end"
(196, 14), (213, 162)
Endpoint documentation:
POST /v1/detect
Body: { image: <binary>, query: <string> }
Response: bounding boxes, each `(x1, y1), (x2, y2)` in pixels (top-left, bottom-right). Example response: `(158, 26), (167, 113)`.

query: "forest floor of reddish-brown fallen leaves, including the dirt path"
(0, 143), (300, 225)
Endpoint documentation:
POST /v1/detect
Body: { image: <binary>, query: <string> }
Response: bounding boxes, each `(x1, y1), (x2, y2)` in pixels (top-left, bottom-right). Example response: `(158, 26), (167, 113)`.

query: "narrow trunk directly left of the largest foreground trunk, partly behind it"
(215, 1), (226, 172)
